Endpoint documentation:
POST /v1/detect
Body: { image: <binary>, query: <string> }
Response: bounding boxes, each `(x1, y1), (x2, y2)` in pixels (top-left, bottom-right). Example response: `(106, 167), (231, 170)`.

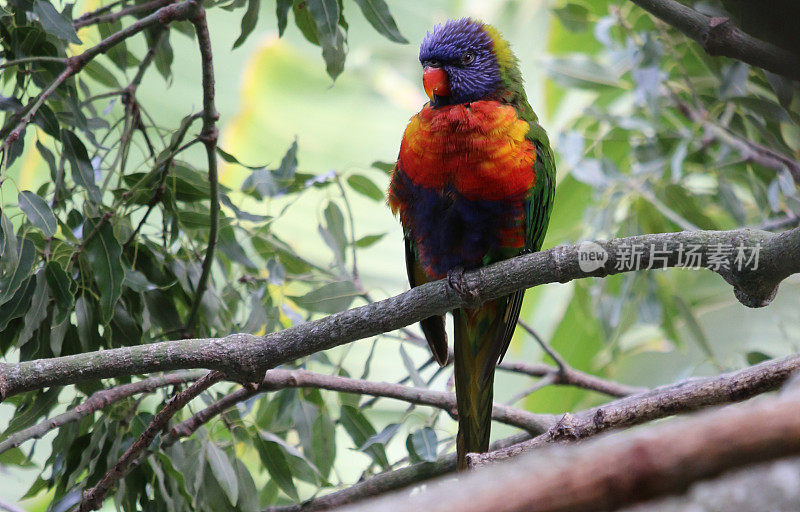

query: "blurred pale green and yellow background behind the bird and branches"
(0, 0), (800, 510)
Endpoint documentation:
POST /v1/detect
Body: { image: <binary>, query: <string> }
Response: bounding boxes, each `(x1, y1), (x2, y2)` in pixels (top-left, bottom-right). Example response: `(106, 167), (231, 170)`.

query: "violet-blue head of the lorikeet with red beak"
(419, 18), (516, 107)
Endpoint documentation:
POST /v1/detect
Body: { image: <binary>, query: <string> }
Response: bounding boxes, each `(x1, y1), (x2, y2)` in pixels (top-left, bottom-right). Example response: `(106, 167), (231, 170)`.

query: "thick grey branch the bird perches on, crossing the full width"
(0, 228), (800, 399)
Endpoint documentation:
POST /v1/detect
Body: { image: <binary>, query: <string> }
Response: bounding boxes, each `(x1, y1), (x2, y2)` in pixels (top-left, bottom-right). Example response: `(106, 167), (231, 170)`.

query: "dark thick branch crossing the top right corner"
(631, 0), (800, 80)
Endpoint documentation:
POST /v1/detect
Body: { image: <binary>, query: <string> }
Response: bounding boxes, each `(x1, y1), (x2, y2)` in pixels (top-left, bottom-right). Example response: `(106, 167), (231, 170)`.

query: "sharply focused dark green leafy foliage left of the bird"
(0, 0), (404, 511)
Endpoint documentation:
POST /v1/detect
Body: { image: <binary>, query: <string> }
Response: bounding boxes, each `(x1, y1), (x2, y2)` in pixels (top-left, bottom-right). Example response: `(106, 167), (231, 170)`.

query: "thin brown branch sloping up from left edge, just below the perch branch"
(0, 371), (205, 453)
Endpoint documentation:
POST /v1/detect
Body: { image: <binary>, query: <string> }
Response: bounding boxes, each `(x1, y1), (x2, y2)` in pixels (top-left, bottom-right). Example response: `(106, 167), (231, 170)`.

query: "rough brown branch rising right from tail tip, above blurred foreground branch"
(467, 355), (800, 467)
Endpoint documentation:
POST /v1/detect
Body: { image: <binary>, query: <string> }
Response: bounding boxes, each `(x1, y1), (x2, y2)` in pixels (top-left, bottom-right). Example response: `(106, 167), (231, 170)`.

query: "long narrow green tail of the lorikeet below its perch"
(453, 302), (498, 470)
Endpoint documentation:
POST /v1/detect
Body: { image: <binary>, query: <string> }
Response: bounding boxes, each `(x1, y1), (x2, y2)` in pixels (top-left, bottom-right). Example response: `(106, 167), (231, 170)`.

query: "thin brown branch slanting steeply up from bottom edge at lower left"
(79, 372), (225, 512)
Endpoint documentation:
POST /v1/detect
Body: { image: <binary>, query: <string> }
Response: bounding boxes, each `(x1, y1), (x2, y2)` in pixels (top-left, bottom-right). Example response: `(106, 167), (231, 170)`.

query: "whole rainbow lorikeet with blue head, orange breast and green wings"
(389, 18), (555, 469)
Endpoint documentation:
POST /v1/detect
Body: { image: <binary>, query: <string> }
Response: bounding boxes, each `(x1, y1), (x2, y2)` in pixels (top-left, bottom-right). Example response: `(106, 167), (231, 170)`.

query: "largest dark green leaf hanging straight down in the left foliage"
(83, 218), (125, 324)
